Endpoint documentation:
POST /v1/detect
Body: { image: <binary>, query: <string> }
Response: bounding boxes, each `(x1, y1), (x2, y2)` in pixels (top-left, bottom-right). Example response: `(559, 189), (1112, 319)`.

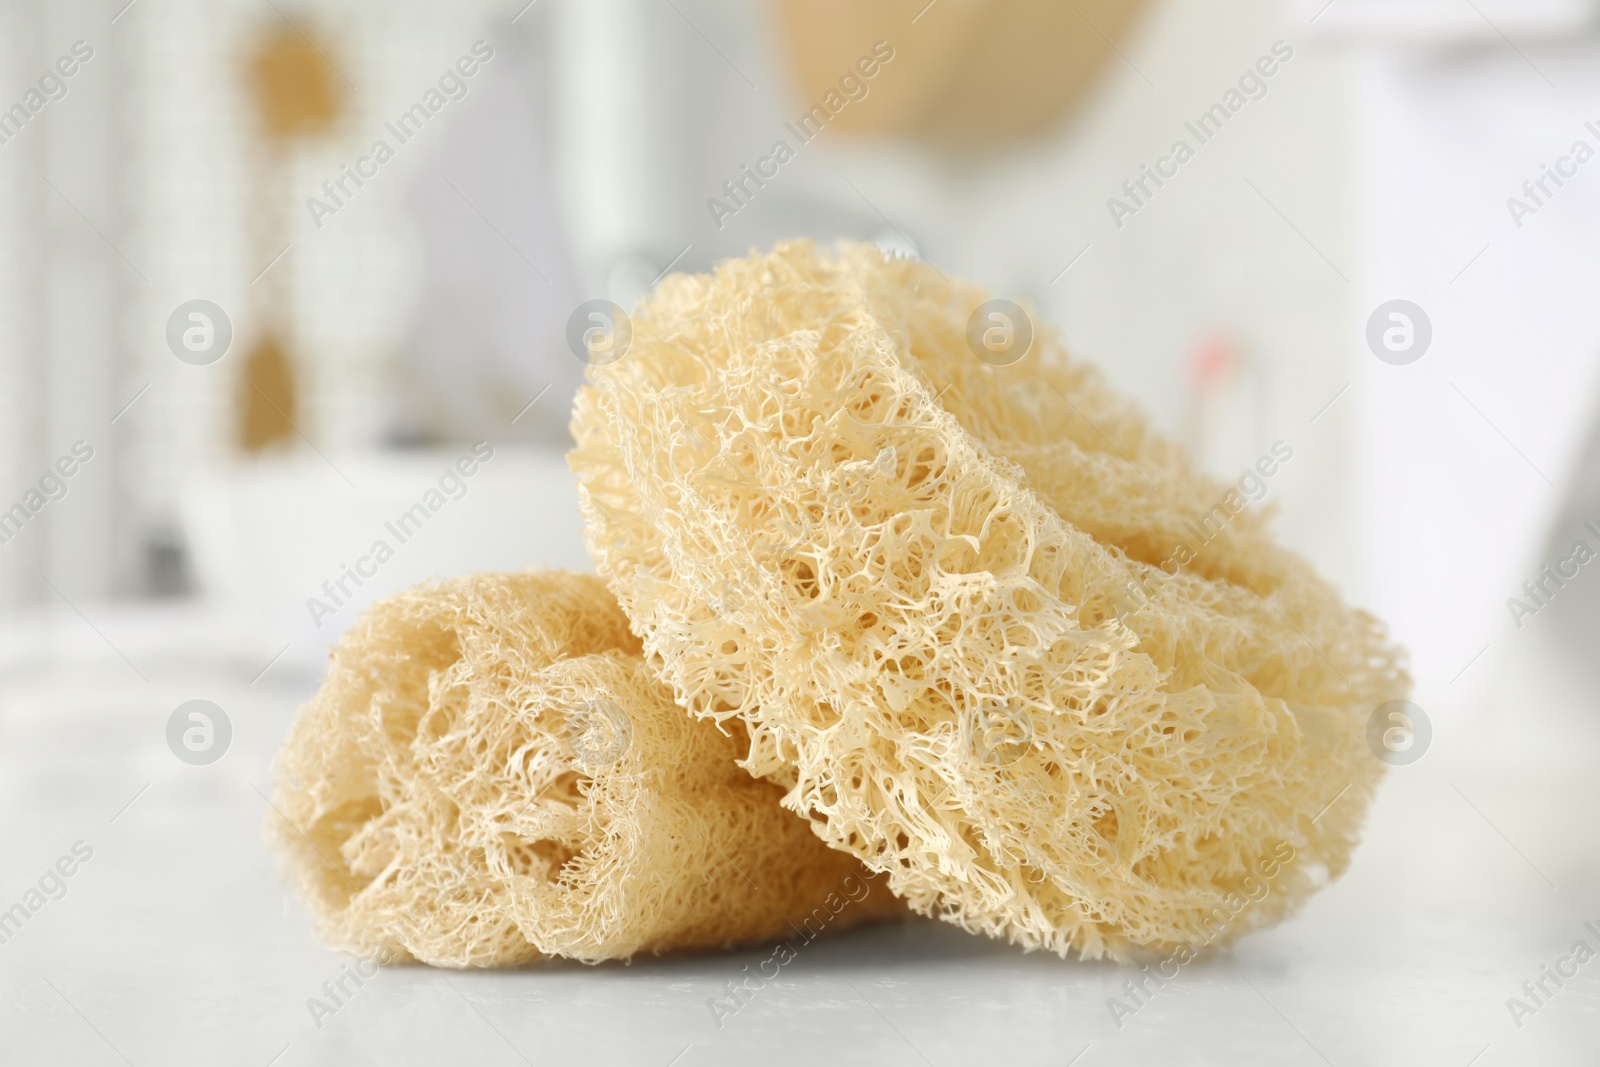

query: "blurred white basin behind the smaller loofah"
(182, 445), (592, 667)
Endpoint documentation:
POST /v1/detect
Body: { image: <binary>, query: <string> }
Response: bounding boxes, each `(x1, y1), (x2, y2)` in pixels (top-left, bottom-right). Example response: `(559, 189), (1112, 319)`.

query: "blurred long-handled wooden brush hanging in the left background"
(234, 19), (342, 453)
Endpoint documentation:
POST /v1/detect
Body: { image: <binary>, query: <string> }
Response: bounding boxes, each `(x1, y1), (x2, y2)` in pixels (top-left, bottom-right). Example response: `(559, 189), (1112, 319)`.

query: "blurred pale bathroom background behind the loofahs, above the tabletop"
(0, 0), (1600, 715)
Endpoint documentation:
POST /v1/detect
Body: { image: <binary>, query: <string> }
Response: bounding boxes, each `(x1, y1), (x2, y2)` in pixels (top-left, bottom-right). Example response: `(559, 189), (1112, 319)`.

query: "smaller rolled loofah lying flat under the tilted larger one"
(267, 571), (901, 968)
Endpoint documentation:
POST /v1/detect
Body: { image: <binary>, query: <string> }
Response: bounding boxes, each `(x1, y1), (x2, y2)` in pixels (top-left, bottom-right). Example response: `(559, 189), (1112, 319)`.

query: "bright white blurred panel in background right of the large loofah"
(1357, 40), (1600, 705)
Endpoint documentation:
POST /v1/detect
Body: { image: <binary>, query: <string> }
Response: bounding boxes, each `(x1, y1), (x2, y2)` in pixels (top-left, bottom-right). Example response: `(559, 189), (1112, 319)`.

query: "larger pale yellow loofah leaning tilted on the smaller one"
(570, 243), (1406, 957)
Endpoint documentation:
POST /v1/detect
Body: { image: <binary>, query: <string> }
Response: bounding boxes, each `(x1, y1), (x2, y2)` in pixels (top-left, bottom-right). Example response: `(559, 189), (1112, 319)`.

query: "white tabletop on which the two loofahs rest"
(0, 606), (1600, 1067)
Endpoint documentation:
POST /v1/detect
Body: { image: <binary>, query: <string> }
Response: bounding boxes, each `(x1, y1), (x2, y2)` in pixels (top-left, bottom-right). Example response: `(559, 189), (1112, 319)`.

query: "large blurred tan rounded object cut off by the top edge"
(776, 0), (1146, 152)
